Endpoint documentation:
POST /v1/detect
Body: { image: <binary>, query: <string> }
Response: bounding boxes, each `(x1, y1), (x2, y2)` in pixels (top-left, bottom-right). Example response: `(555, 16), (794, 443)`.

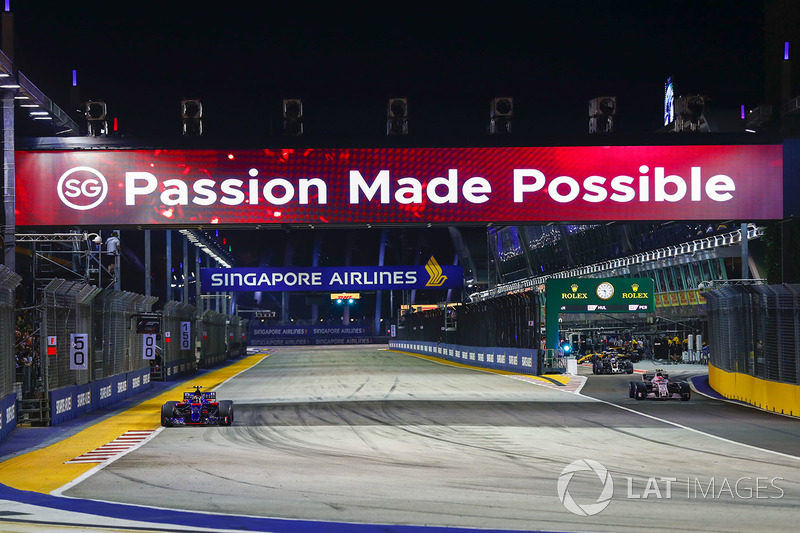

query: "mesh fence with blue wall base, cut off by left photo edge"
(0, 265), (22, 440)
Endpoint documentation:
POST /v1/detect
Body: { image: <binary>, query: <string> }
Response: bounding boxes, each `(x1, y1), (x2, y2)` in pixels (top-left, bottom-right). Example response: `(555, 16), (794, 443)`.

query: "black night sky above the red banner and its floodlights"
(11, 0), (764, 143)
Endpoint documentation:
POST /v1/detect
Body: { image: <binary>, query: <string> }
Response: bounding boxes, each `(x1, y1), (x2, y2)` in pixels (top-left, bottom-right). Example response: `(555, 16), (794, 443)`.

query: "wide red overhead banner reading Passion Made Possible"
(15, 145), (783, 226)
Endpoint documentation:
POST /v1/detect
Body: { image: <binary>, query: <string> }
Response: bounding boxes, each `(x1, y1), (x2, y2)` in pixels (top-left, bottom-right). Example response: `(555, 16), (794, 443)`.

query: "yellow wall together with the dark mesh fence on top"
(703, 284), (800, 416)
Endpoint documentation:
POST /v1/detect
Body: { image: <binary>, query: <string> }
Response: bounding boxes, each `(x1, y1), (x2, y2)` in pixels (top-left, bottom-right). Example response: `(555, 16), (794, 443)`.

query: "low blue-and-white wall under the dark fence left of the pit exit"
(389, 341), (539, 375)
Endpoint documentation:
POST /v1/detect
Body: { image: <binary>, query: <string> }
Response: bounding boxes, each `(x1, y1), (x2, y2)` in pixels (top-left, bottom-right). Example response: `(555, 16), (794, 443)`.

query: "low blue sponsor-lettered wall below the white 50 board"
(50, 368), (150, 425)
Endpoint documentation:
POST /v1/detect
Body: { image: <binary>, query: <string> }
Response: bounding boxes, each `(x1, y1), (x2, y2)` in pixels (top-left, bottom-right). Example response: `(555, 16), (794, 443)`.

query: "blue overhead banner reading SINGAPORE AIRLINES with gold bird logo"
(200, 257), (464, 293)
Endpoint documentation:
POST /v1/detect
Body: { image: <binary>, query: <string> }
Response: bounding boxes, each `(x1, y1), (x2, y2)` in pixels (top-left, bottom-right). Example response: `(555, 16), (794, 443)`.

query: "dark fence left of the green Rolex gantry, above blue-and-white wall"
(398, 291), (540, 348)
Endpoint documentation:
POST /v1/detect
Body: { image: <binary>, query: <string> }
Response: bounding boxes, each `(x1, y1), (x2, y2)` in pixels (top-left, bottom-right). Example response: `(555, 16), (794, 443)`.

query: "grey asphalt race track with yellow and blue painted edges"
(0, 346), (800, 532)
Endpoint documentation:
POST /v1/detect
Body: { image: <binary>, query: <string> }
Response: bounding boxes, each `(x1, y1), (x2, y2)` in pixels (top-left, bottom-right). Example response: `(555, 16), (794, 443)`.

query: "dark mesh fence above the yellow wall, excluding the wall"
(704, 285), (800, 384)
